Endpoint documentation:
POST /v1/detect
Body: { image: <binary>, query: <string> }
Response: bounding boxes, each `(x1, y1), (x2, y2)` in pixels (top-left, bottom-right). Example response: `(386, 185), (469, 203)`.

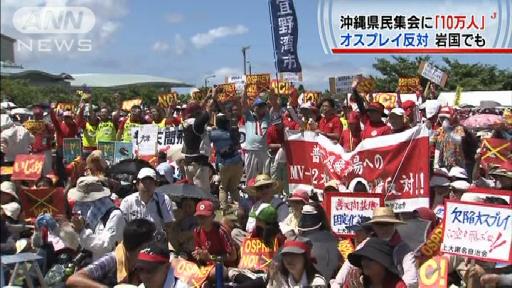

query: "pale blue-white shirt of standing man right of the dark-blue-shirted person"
(245, 111), (270, 150)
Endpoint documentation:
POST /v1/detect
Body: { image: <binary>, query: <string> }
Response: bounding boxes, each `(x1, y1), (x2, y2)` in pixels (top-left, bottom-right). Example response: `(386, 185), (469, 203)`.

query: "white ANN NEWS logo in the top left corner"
(12, 6), (96, 52)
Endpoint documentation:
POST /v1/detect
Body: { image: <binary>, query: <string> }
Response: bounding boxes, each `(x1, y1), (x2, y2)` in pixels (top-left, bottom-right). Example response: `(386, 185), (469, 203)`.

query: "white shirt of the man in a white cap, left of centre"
(120, 192), (175, 230)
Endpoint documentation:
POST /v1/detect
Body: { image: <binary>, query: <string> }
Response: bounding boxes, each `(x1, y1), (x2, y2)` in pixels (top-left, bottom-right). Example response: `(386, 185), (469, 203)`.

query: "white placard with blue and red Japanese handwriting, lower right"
(441, 200), (512, 263)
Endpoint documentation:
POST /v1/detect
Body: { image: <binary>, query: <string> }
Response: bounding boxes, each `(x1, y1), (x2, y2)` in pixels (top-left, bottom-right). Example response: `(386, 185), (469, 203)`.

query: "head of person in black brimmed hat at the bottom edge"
(348, 238), (409, 288)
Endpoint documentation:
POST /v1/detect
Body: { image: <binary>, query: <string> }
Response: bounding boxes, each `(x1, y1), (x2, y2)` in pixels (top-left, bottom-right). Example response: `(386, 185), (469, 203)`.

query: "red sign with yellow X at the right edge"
(480, 138), (512, 166)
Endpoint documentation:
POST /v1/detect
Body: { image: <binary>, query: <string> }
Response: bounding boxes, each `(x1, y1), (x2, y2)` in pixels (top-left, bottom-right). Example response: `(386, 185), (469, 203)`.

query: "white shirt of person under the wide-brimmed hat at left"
(80, 209), (126, 261)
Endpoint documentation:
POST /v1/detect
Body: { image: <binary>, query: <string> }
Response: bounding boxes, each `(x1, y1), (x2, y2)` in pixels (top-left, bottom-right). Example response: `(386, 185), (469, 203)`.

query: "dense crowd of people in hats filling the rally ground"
(0, 80), (512, 288)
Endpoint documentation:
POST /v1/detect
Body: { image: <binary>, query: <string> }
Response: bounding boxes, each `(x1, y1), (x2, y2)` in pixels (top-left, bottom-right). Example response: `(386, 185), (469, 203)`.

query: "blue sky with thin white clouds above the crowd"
(1, 0), (512, 90)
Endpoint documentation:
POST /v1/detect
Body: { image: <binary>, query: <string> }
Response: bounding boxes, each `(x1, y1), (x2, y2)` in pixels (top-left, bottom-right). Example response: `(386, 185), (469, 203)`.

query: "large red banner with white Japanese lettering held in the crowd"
(285, 126), (429, 212)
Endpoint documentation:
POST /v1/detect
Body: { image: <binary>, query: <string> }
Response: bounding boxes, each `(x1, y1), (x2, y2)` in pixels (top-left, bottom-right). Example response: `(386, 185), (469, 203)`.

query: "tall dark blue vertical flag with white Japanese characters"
(269, 0), (302, 73)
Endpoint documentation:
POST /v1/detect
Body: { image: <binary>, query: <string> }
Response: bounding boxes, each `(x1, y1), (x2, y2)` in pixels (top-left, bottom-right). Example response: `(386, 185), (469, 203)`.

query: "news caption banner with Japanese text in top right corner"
(317, 0), (512, 54)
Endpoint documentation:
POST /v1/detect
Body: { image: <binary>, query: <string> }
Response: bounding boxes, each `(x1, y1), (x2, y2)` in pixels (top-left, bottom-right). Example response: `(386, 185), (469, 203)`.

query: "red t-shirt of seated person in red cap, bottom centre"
(194, 222), (235, 266)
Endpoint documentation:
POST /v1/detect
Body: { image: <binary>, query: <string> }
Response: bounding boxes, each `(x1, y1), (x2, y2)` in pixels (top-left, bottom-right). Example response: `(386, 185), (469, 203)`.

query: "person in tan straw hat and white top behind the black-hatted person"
(366, 207), (418, 287)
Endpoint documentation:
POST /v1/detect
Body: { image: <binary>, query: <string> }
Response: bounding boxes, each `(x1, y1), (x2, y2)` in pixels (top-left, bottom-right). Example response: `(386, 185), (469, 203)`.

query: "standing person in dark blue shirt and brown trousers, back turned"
(210, 114), (244, 210)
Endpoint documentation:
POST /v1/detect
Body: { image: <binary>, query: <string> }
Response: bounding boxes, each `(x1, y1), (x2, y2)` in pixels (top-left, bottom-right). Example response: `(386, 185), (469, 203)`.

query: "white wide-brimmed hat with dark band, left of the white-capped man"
(68, 176), (110, 202)
